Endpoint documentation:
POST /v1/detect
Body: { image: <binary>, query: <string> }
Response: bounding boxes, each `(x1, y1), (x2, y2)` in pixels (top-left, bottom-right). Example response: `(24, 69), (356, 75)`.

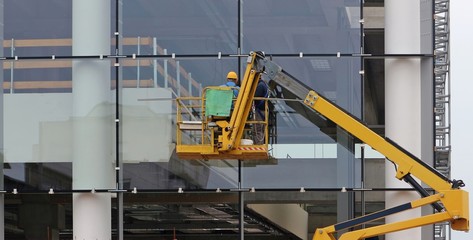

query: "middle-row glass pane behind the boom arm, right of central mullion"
(243, 57), (361, 188)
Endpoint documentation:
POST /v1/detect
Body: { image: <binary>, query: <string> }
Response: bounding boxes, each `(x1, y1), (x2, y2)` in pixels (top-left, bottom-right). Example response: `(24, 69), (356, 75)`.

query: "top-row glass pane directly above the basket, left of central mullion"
(123, 0), (238, 54)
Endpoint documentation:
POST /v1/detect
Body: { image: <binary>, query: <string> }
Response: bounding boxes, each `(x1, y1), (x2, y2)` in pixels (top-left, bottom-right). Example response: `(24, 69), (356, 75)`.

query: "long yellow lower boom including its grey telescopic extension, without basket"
(262, 55), (469, 240)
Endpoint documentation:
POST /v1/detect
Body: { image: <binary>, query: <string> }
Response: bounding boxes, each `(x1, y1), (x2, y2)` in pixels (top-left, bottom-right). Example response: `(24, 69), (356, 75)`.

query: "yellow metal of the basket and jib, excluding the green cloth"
(176, 53), (269, 160)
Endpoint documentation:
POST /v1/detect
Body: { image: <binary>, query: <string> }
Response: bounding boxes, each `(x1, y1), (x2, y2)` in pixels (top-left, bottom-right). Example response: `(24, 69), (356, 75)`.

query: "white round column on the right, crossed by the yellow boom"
(385, 0), (422, 240)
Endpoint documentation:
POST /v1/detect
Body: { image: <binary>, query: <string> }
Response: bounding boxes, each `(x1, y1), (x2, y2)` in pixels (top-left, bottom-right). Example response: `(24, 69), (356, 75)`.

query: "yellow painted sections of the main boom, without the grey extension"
(304, 91), (469, 240)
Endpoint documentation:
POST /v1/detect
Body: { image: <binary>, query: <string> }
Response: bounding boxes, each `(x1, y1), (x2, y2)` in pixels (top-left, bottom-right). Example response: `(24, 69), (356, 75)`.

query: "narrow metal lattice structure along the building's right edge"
(434, 0), (451, 240)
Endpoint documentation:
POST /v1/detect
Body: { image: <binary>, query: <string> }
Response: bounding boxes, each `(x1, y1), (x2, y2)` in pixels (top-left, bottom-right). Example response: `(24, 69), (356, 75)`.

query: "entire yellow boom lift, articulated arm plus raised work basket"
(176, 52), (469, 240)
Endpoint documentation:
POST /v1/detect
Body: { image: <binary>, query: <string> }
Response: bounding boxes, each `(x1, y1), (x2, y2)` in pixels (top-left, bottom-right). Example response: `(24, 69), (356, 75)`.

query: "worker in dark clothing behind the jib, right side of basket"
(253, 78), (269, 145)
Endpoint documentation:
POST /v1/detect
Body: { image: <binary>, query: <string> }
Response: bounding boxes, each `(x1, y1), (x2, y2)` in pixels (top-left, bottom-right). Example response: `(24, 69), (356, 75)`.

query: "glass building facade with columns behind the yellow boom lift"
(0, 0), (446, 240)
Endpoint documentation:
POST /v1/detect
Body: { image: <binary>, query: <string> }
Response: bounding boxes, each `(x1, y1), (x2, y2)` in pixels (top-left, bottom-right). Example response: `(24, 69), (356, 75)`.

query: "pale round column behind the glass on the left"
(72, 0), (115, 240)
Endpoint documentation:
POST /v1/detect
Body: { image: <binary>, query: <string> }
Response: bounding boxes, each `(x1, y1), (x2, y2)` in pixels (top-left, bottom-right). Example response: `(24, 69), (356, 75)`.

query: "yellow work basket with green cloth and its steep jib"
(176, 52), (269, 160)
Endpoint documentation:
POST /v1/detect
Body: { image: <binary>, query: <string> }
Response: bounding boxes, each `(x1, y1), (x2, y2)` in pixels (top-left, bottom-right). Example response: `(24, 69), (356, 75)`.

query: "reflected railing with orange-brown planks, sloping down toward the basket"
(3, 37), (202, 96)
